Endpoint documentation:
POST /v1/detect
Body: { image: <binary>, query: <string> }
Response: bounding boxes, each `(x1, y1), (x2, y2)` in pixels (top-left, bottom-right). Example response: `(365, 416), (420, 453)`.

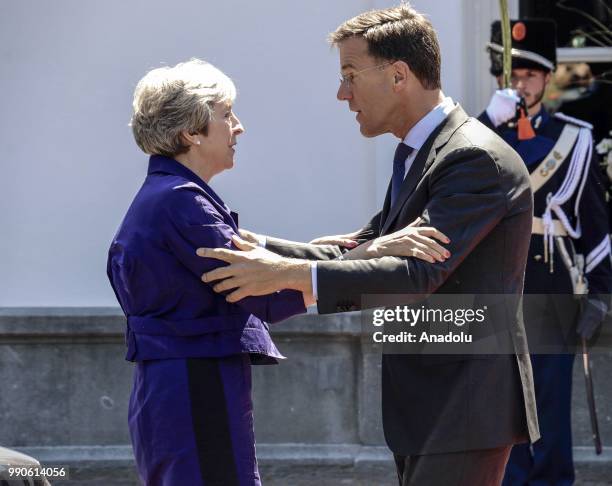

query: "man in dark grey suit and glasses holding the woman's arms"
(198, 5), (539, 486)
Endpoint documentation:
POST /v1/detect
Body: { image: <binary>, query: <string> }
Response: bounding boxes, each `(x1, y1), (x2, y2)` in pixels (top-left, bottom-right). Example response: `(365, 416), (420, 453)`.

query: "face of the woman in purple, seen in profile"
(198, 101), (244, 174)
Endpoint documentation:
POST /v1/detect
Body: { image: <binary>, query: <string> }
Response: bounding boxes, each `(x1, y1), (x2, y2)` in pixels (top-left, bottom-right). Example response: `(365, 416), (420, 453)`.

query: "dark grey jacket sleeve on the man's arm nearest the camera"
(317, 147), (507, 314)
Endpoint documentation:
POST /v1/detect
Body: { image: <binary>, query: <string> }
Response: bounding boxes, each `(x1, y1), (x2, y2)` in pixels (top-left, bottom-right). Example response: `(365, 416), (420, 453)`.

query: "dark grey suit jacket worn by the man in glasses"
(267, 106), (539, 455)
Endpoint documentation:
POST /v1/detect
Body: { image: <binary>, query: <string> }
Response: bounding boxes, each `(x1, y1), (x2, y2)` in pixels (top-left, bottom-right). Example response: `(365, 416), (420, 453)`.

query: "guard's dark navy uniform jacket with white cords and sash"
(479, 108), (612, 352)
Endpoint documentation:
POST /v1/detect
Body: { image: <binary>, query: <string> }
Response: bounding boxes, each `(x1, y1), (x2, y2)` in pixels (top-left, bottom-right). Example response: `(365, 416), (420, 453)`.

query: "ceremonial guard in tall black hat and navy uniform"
(479, 19), (612, 486)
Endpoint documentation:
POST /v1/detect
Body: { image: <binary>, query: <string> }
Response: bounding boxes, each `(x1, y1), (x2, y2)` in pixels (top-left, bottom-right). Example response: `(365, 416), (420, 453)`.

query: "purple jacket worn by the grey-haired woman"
(107, 155), (305, 362)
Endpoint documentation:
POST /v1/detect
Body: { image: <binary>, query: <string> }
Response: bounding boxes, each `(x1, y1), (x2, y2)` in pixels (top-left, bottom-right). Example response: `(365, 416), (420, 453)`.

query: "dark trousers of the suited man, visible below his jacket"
(394, 446), (512, 486)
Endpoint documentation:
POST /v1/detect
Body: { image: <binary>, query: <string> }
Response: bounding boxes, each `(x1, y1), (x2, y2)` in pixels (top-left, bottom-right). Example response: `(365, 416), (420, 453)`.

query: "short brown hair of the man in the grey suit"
(329, 4), (441, 89)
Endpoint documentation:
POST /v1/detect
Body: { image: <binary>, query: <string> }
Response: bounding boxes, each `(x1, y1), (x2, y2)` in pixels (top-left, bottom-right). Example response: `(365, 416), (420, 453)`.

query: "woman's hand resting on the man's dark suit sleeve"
(344, 218), (450, 263)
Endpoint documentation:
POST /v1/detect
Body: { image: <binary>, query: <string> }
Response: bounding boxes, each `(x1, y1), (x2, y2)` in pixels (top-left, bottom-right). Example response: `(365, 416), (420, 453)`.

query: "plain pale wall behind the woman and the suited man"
(0, 0), (512, 306)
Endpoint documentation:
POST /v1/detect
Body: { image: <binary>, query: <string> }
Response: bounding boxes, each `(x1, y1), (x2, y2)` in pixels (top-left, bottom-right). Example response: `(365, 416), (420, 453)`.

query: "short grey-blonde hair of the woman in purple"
(130, 59), (236, 157)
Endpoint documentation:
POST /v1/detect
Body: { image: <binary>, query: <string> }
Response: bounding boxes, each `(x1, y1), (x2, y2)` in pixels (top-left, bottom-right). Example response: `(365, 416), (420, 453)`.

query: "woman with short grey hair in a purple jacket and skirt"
(108, 59), (305, 486)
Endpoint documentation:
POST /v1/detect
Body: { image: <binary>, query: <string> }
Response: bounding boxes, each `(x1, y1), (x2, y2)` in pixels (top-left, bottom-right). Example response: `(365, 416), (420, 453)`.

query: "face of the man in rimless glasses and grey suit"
(337, 37), (393, 137)
